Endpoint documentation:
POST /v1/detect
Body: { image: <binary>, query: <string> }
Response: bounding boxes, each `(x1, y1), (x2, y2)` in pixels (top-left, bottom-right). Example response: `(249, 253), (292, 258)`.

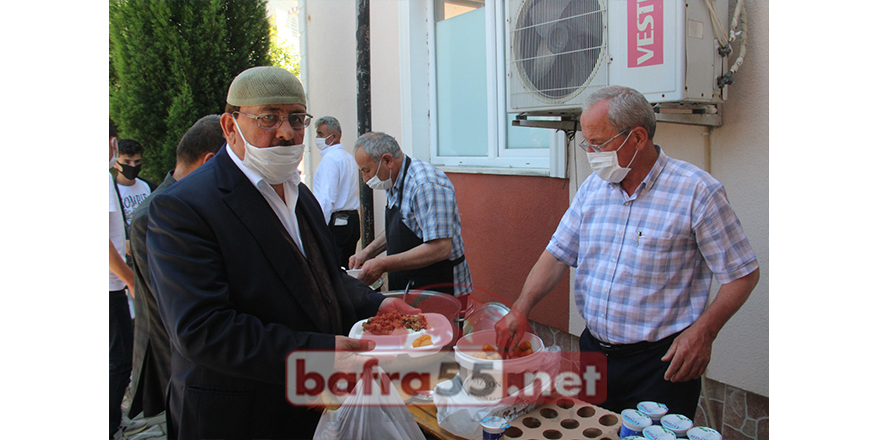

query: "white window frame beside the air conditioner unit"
(398, 0), (567, 177)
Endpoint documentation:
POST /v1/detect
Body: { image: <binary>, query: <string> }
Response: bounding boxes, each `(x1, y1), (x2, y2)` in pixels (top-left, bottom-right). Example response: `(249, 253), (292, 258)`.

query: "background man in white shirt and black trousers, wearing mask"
(312, 116), (361, 269)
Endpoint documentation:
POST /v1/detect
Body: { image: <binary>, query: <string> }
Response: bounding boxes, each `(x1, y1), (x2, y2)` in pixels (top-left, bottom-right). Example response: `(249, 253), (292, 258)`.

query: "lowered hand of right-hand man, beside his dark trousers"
(660, 326), (714, 382)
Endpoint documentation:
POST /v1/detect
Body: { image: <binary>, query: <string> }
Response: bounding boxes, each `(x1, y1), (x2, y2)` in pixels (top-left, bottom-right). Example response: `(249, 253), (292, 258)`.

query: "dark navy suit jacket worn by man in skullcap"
(147, 147), (384, 440)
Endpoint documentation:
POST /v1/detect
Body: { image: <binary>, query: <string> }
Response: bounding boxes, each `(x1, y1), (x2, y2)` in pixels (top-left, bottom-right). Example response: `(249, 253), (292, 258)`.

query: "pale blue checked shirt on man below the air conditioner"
(547, 146), (758, 344)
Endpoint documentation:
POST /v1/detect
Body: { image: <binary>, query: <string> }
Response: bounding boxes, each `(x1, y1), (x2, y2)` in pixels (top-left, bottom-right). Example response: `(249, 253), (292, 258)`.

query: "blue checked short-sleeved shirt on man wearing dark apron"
(386, 157), (473, 296)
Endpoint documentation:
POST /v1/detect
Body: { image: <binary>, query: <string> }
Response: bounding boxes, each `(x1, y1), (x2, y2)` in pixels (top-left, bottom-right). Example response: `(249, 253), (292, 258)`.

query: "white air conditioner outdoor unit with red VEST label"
(506, 0), (728, 115)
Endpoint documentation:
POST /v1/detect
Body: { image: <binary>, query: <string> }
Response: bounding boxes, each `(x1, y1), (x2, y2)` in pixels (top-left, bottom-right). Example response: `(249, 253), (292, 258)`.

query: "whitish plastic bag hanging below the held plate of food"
(314, 368), (425, 440)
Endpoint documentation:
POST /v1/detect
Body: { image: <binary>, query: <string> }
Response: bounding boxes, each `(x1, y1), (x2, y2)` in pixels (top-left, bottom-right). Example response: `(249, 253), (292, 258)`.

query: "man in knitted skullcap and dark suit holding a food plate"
(147, 67), (418, 439)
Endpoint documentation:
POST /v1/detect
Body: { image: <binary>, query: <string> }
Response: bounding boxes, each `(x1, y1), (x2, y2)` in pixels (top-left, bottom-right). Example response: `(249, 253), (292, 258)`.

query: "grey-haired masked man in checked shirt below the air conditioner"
(495, 86), (759, 419)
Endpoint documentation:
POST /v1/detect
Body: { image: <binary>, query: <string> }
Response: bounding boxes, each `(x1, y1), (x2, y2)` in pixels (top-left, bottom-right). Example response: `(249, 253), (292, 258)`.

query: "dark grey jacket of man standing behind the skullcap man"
(128, 171), (176, 418)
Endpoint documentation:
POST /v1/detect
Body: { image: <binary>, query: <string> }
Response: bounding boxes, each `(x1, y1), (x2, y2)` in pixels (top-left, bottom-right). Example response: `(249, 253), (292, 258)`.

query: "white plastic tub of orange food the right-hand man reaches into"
(454, 330), (544, 400)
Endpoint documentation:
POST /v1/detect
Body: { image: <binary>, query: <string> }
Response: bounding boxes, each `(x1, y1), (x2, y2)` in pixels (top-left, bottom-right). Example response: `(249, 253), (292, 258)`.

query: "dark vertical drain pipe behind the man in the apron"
(355, 0), (375, 244)
